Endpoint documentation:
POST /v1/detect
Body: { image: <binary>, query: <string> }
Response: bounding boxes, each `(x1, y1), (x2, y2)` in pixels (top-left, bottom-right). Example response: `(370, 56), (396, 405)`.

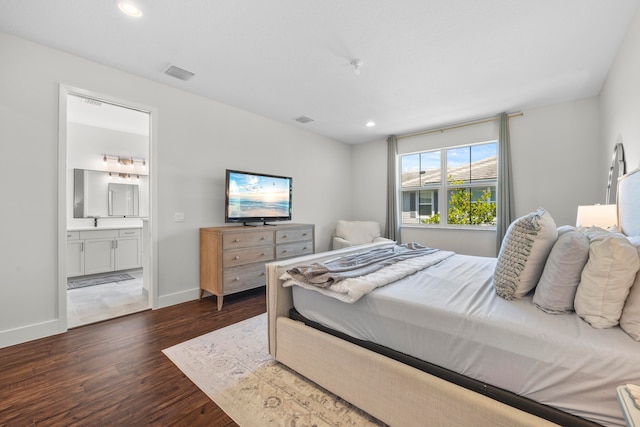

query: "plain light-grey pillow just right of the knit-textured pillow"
(533, 225), (589, 314)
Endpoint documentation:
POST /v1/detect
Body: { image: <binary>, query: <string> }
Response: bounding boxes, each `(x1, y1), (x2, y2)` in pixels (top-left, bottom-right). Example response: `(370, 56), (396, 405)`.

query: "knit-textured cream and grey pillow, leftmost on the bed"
(493, 209), (558, 300)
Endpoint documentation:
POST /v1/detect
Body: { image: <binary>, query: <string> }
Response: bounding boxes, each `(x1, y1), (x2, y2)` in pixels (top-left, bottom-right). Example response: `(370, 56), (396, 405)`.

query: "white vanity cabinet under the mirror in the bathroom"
(67, 228), (142, 277)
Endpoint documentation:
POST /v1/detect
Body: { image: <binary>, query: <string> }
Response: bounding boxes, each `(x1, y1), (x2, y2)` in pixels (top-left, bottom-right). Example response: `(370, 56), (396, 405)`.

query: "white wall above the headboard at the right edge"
(600, 7), (640, 174)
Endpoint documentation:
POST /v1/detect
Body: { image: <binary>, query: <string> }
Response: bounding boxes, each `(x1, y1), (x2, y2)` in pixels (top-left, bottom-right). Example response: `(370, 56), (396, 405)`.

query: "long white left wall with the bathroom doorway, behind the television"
(0, 33), (351, 347)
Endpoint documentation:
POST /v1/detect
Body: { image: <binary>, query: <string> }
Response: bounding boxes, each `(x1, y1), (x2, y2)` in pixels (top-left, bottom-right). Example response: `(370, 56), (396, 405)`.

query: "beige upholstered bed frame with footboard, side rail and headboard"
(267, 171), (640, 427)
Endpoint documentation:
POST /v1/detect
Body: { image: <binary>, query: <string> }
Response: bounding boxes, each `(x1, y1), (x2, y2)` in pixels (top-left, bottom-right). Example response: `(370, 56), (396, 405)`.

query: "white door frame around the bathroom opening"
(57, 84), (158, 332)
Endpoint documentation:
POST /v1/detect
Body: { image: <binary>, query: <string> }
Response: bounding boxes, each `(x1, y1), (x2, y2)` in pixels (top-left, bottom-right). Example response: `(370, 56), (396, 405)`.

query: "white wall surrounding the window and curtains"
(352, 98), (606, 256)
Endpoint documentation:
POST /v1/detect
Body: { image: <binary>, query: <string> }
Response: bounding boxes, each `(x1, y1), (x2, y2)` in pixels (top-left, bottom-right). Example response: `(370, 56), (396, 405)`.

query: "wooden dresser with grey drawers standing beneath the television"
(200, 224), (315, 310)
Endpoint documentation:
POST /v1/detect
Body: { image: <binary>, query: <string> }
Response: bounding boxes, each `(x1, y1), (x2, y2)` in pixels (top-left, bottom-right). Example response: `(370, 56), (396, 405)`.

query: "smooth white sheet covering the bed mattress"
(293, 255), (640, 426)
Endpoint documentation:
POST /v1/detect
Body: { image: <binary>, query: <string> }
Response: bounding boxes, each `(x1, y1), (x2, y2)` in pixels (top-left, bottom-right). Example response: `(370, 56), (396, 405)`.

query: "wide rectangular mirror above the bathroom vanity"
(73, 169), (149, 218)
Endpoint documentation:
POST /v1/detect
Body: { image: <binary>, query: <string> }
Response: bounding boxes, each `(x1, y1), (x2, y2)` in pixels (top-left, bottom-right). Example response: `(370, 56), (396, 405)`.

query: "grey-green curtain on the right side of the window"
(496, 113), (515, 254)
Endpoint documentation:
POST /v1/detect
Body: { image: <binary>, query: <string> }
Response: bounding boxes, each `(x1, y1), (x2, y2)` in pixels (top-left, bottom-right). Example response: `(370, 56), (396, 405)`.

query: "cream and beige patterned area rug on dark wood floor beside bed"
(163, 314), (384, 427)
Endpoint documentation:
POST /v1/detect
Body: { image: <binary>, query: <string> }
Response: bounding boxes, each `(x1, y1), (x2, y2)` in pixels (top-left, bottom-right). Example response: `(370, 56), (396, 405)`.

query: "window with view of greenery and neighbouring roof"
(400, 141), (498, 226)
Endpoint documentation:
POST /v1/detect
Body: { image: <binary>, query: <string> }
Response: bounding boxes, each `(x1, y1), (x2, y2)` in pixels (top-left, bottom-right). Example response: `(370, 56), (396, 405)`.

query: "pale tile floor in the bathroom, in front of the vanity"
(67, 269), (149, 328)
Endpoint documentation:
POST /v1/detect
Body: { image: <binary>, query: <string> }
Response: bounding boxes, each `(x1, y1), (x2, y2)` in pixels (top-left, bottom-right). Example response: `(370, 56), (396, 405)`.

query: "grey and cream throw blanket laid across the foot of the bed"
(280, 243), (454, 303)
